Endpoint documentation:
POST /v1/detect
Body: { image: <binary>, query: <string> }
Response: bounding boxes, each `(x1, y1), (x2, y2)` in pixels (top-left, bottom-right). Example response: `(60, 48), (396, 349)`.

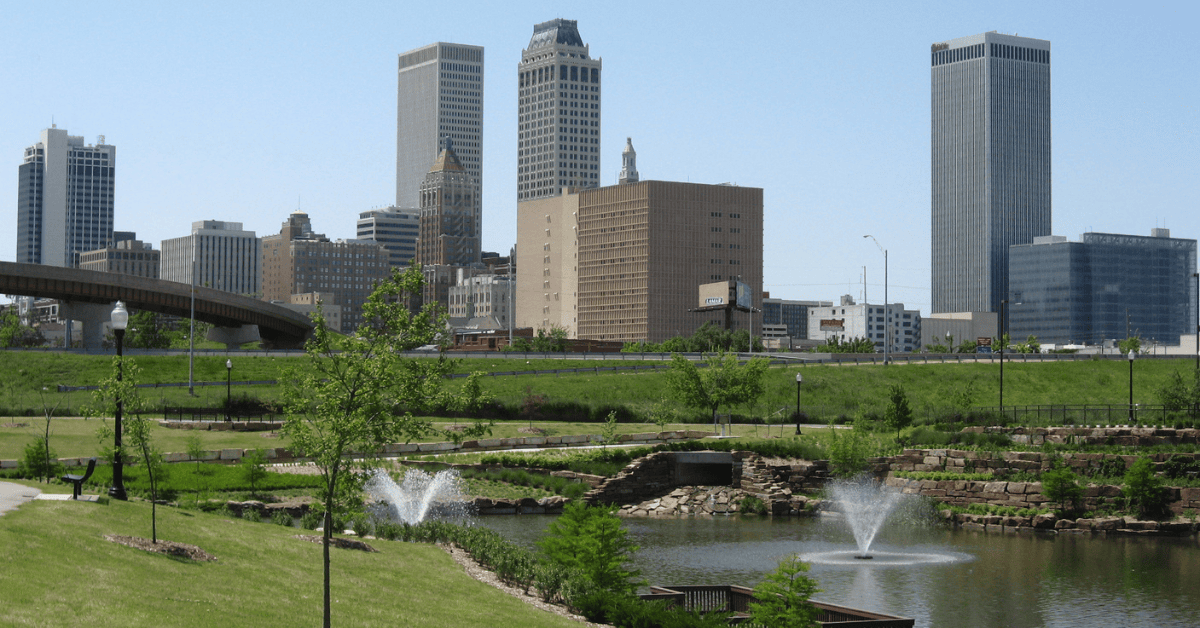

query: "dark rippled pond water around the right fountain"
(478, 515), (1200, 628)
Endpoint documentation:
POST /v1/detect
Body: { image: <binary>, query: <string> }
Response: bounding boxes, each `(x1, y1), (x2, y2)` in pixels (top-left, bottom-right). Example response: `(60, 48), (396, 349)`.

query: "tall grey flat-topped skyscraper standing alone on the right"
(930, 31), (1050, 313)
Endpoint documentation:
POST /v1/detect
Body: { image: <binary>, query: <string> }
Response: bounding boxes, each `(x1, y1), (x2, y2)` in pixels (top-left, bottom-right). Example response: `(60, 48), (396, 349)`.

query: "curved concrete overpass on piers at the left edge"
(0, 262), (313, 349)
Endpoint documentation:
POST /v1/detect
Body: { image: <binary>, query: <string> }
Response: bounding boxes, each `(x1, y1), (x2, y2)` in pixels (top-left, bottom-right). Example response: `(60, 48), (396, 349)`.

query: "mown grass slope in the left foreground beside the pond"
(0, 499), (578, 628)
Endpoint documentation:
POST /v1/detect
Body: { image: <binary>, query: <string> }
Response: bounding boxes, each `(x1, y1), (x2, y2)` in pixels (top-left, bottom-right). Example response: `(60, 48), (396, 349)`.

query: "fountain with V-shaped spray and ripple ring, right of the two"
(802, 476), (971, 567)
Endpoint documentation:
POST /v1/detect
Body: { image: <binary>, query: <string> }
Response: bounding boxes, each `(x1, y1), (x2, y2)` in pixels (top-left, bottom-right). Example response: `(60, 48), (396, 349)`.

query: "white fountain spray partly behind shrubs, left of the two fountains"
(362, 468), (473, 525)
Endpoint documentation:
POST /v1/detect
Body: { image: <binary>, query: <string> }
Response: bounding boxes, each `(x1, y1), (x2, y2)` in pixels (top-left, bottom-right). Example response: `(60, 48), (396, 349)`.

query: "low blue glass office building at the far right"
(1000, 229), (1196, 345)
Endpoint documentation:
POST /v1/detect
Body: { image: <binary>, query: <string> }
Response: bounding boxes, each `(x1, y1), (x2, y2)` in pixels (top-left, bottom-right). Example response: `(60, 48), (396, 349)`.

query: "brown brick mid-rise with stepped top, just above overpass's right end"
(263, 211), (391, 334)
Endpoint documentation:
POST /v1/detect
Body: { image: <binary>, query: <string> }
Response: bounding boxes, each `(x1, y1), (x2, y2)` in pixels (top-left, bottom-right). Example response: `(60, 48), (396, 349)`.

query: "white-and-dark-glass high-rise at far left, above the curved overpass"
(17, 127), (116, 268)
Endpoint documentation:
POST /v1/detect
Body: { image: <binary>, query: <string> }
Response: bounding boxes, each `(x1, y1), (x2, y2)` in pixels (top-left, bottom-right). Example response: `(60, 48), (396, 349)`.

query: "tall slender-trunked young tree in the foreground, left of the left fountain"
(283, 265), (487, 627)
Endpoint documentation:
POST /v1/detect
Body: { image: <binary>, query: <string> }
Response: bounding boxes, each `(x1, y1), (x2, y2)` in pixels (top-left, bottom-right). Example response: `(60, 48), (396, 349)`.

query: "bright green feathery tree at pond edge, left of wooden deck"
(538, 502), (641, 593)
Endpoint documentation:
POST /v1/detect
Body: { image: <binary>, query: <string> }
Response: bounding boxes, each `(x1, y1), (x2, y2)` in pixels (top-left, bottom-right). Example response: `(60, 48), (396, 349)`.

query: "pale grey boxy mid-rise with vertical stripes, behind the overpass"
(160, 220), (263, 295)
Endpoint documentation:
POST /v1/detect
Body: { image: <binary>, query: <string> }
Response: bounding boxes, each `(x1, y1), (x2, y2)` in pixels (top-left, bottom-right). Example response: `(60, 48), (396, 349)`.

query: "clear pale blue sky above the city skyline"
(0, 0), (1200, 316)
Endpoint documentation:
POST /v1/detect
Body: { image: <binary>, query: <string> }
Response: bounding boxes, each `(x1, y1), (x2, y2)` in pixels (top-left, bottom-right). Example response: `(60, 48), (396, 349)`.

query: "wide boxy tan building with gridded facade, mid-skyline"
(516, 181), (762, 342)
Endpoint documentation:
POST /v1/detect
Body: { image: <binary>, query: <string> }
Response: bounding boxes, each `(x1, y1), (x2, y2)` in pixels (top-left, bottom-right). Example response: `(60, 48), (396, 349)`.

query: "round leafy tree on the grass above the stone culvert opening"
(667, 352), (768, 427)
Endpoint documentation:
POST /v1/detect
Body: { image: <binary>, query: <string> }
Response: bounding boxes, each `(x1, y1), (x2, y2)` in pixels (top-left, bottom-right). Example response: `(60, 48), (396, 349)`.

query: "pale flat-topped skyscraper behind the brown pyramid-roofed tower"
(396, 42), (484, 210)
